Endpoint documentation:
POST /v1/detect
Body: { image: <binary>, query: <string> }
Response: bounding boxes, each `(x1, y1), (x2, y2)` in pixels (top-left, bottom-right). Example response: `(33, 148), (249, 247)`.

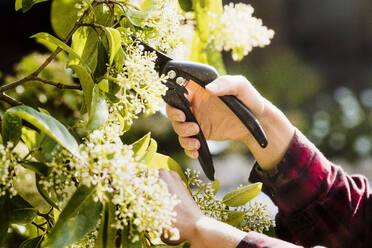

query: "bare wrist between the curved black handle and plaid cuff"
(243, 100), (295, 170)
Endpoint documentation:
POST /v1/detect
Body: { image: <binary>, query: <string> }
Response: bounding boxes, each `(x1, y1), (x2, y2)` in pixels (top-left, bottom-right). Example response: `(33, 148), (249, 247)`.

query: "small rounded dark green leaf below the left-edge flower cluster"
(7, 195), (37, 225)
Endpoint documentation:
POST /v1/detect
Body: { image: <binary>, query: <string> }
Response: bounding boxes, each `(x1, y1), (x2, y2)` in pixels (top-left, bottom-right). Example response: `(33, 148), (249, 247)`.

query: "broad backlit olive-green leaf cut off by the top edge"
(50, 0), (79, 39)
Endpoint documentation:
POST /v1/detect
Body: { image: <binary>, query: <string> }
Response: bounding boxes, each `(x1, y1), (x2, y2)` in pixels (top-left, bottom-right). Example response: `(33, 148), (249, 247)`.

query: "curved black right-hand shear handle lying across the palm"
(219, 95), (267, 148)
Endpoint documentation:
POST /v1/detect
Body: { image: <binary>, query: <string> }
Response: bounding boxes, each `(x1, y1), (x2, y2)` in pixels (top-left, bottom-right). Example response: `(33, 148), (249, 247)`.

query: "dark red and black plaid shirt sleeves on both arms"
(238, 131), (372, 248)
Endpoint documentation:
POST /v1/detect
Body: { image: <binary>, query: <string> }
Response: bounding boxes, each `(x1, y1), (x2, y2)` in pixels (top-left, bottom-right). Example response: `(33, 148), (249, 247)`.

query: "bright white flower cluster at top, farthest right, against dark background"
(212, 3), (274, 60)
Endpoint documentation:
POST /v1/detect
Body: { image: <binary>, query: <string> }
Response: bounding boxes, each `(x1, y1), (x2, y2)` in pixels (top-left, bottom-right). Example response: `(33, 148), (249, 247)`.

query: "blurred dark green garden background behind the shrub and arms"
(0, 0), (372, 178)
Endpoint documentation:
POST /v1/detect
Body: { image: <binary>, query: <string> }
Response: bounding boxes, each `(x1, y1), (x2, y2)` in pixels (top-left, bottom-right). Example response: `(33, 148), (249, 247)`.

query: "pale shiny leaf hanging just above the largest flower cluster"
(87, 85), (109, 130)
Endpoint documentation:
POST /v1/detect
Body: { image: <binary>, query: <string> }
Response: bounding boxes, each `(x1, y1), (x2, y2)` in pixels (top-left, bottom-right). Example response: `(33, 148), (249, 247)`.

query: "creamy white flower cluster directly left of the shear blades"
(111, 44), (167, 126)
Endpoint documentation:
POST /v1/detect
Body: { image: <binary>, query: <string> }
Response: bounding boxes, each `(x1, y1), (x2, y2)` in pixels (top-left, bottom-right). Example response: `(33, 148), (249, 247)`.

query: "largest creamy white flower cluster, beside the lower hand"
(71, 123), (178, 241)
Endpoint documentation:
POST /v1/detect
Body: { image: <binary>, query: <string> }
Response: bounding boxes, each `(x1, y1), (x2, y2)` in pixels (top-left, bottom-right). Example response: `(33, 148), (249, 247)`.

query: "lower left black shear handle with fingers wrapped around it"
(164, 89), (214, 181)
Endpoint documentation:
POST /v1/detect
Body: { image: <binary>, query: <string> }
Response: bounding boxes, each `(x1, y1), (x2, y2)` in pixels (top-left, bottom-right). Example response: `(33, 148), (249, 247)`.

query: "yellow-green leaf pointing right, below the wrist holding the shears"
(222, 183), (262, 207)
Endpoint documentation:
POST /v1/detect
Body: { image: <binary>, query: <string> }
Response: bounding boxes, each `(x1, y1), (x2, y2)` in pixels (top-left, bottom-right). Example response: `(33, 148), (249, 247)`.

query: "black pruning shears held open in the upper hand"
(140, 42), (267, 181)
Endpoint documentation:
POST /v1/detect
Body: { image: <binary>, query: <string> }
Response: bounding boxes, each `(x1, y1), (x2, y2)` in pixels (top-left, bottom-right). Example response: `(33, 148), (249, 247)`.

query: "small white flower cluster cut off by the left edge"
(0, 142), (18, 197)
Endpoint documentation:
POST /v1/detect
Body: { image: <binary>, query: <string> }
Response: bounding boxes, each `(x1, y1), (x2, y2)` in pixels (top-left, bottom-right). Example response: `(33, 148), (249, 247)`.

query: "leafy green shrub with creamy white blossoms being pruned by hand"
(0, 0), (273, 247)
